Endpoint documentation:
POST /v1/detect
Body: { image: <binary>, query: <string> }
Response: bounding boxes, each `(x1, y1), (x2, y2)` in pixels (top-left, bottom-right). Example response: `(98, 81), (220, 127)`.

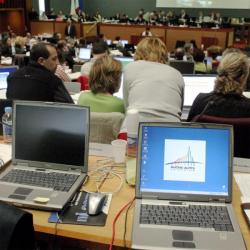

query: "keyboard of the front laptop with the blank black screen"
(1, 169), (79, 192)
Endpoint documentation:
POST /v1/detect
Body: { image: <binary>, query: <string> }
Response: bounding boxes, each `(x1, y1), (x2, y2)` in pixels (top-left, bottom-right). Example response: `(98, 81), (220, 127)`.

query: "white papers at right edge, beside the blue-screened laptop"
(234, 173), (250, 226)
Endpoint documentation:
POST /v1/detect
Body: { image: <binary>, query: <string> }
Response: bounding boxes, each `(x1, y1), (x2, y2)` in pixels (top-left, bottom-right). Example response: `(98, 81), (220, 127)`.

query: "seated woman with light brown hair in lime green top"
(77, 55), (125, 113)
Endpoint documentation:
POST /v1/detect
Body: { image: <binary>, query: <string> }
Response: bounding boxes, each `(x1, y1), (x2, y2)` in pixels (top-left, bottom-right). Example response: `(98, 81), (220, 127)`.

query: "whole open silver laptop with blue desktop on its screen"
(132, 123), (245, 250)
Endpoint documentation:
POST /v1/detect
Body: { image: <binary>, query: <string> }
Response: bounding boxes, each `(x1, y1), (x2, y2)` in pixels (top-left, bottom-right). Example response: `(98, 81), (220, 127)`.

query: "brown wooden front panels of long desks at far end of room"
(30, 21), (234, 51)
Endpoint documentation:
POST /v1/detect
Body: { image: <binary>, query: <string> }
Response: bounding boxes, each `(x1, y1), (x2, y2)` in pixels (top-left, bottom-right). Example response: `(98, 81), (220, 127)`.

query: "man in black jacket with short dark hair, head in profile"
(6, 43), (73, 103)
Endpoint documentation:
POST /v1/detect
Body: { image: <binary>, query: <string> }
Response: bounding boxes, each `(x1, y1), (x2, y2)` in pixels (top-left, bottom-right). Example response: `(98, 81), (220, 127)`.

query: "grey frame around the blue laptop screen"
(136, 122), (233, 202)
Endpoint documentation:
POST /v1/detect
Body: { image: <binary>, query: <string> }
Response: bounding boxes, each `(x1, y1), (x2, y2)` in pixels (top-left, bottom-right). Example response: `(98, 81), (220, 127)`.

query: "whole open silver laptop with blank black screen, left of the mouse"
(0, 101), (89, 210)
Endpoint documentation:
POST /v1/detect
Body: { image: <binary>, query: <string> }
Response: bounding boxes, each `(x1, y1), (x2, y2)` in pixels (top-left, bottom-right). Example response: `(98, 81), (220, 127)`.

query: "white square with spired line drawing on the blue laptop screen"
(163, 139), (206, 182)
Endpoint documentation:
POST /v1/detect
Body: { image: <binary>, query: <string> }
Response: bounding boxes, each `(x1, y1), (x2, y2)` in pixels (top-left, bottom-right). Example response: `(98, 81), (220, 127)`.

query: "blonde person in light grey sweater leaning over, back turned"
(123, 37), (184, 122)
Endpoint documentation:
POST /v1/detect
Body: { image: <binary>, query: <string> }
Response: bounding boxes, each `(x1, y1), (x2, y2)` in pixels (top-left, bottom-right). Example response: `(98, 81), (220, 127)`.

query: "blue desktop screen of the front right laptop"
(138, 123), (231, 196)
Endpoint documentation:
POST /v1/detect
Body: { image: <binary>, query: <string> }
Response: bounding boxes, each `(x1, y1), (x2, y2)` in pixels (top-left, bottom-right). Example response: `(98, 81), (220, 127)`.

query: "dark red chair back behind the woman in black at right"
(192, 115), (250, 158)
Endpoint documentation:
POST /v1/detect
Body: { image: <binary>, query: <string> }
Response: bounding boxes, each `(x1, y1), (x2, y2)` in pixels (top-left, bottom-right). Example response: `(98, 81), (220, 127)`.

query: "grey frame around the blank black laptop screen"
(12, 100), (90, 173)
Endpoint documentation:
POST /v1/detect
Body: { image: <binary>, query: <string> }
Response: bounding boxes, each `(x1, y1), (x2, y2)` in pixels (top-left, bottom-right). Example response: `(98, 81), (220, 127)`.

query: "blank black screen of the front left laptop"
(12, 101), (89, 168)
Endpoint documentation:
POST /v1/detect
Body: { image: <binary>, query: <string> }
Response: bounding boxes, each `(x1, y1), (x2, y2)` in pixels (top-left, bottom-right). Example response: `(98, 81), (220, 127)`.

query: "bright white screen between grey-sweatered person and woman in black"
(183, 75), (216, 107)
